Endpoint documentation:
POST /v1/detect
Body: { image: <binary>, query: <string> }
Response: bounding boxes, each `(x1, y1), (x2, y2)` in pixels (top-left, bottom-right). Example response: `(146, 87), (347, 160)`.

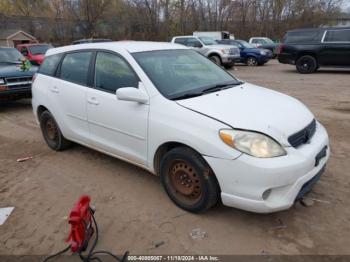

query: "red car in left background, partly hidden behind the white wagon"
(17, 44), (52, 65)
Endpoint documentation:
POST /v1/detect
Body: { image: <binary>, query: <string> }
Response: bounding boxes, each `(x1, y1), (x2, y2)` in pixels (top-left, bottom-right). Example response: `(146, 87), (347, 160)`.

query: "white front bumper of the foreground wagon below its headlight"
(204, 123), (330, 213)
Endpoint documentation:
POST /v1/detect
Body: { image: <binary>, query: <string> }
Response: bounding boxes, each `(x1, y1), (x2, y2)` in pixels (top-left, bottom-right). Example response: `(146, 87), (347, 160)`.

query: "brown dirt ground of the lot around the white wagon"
(0, 60), (350, 255)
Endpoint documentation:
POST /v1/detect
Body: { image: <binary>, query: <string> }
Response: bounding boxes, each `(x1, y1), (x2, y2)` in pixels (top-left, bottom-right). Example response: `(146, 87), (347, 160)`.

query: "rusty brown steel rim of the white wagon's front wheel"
(170, 160), (202, 204)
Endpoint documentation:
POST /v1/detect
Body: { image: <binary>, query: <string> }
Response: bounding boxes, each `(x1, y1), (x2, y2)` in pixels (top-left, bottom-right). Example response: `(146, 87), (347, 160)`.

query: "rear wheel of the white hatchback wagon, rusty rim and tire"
(40, 111), (71, 151)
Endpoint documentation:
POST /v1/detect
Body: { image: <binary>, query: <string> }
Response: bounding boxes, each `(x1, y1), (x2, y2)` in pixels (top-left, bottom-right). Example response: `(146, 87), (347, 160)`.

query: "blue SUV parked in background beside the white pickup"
(217, 39), (273, 66)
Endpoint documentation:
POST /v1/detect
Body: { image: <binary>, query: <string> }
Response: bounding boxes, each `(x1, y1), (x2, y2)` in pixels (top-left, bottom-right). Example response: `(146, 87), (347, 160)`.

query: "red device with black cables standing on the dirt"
(43, 195), (129, 262)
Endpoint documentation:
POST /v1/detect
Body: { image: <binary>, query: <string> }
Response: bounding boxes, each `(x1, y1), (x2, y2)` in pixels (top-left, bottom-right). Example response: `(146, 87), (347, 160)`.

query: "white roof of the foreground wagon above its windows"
(46, 41), (188, 56)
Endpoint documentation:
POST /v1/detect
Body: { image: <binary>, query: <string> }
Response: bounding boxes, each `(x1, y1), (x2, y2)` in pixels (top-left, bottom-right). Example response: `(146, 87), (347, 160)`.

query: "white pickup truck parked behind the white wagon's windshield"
(171, 36), (240, 69)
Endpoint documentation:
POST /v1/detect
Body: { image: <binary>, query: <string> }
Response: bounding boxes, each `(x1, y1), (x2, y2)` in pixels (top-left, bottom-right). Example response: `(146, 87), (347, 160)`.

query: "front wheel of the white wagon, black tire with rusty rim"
(160, 147), (220, 213)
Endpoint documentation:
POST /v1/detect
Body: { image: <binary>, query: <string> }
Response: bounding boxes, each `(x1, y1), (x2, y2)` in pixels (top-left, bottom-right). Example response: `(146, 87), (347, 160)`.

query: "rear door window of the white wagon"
(60, 52), (92, 85)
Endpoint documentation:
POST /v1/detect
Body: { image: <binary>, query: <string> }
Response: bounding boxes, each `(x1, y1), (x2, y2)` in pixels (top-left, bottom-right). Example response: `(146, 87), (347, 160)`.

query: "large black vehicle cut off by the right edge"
(278, 27), (350, 74)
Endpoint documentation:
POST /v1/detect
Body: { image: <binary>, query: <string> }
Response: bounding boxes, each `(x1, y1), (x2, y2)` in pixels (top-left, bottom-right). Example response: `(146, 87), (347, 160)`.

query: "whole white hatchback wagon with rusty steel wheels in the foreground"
(32, 42), (330, 213)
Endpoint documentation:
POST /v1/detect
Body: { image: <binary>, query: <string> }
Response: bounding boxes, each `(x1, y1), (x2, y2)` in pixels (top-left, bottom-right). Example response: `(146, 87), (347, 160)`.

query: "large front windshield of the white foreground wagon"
(133, 50), (240, 99)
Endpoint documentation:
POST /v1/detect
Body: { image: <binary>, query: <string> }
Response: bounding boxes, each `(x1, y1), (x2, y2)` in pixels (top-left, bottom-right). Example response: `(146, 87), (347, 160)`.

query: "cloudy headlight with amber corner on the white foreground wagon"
(219, 129), (287, 158)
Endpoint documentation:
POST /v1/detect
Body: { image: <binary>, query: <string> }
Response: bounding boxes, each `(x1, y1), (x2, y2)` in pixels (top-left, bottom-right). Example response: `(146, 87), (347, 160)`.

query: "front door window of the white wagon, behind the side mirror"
(95, 52), (139, 93)
